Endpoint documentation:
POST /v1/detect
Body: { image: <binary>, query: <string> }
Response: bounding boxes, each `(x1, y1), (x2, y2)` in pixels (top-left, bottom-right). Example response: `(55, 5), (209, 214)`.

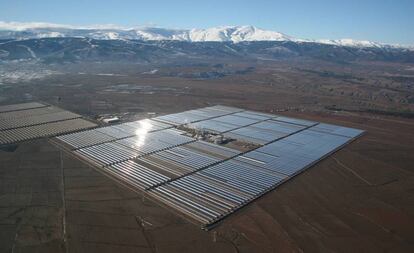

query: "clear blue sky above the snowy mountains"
(0, 0), (414, 45)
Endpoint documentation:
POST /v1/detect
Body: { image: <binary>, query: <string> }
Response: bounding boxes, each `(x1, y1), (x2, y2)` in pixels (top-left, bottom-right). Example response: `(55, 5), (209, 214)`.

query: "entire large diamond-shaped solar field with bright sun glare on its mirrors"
(55, 105), (363, 229)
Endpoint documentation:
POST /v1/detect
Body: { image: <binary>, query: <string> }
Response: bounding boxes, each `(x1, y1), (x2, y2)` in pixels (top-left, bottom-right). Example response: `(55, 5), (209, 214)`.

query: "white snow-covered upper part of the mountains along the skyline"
(0, 21), (406, 48)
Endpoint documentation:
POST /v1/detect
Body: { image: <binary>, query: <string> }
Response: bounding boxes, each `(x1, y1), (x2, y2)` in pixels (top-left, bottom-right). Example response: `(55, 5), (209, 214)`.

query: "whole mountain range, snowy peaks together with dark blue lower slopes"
(0, 22), (414, 63)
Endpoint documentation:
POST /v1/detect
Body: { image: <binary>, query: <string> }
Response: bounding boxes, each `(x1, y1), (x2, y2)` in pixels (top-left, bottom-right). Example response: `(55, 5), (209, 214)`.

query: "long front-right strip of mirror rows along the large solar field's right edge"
(151, 121), (362, 226)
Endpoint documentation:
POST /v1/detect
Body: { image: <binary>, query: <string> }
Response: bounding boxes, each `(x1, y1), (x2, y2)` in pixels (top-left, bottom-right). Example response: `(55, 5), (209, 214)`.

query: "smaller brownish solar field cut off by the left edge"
(0, 102), (96, 144)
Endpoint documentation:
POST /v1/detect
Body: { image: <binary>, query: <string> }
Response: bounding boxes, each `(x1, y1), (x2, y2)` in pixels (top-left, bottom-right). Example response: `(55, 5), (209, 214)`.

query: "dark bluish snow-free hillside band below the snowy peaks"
(0, 37), (414, 63)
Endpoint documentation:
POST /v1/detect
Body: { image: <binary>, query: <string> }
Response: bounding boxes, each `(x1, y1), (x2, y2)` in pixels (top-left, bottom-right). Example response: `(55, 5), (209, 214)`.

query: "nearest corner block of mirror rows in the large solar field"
(150, 161), (284, 225)
